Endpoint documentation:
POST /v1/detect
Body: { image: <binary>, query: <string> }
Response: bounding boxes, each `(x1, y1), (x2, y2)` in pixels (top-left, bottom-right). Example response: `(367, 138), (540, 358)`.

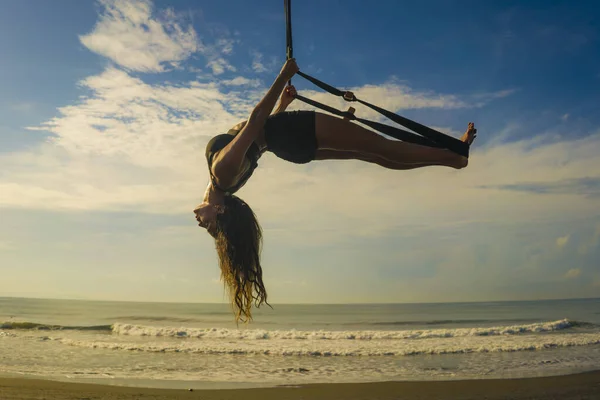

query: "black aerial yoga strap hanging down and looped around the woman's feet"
(284, 0), (469, 157)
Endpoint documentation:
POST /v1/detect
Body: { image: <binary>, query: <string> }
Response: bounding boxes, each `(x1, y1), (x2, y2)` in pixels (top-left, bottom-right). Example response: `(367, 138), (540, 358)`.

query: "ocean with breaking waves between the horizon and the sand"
(0, 297), (600, 389)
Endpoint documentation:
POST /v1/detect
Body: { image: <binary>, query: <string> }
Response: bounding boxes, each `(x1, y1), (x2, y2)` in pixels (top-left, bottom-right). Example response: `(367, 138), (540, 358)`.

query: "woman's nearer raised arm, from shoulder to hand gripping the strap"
(213, 59), (298, 187)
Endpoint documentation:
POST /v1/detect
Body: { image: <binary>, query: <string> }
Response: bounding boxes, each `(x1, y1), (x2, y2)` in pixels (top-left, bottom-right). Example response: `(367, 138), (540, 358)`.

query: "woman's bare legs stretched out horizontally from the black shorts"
(315, 113), (468, 169)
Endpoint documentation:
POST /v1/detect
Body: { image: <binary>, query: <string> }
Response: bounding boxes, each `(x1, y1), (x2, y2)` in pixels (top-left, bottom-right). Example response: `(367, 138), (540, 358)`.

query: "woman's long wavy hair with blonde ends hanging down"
(215, 194), (270, 323)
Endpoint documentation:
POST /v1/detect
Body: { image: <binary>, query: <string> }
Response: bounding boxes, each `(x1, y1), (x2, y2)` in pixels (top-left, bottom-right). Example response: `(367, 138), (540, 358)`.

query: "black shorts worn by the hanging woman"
(265, 111), (318, 164)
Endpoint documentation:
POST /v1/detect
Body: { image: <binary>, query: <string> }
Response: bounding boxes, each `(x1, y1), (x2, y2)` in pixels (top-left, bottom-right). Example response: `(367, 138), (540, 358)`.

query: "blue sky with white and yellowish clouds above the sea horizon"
(0, 0), (600, 303)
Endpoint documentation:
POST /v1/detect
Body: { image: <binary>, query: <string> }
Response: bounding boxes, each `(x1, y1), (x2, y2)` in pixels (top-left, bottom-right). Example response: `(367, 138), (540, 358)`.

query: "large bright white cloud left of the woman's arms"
(24, 68), (247, 164)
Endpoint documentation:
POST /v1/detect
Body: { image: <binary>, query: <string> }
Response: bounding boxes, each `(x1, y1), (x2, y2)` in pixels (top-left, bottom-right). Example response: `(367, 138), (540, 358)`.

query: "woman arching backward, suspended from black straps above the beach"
(194, 59), (476, 322)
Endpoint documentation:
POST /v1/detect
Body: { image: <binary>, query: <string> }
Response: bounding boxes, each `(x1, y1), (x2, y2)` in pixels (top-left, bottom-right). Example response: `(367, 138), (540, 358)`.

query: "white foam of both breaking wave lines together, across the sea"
(41, 320), (600, 357)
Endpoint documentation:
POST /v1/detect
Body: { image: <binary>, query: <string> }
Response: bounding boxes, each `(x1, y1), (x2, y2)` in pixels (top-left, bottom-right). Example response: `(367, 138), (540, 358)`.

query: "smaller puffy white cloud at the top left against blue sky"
(80, 0), (202, 72)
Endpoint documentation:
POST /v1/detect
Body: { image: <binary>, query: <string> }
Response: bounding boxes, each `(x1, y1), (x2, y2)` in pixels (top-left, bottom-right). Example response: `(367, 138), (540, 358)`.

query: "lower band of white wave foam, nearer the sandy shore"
(56, 333), (600, 356)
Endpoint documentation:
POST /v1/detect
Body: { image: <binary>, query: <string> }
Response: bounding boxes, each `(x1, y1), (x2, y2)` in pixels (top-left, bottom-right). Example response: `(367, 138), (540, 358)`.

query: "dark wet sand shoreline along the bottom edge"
(0, 370), (600, 400)
